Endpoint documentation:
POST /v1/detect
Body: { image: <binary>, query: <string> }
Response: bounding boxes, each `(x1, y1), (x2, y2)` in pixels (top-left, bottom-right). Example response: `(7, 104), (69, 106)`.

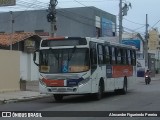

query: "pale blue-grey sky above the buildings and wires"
(0, 0), (160, 36)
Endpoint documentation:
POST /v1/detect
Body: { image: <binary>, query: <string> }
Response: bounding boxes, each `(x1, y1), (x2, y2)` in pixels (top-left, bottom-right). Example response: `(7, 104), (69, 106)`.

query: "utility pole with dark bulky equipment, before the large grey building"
(47, 0), (58, 37)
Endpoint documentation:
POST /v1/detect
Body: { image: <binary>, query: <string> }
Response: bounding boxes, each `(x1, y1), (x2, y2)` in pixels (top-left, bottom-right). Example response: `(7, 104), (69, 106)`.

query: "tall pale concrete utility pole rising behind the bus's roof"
(119, 0), (123, 43)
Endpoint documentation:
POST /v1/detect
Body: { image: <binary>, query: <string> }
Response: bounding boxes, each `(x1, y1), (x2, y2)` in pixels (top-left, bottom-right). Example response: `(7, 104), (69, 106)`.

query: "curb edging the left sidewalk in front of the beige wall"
(0, 95), (51, 105)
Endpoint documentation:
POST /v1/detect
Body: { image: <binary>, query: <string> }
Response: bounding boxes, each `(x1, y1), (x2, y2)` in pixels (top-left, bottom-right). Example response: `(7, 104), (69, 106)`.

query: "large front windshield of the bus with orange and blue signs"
(39, 47), (90, 73)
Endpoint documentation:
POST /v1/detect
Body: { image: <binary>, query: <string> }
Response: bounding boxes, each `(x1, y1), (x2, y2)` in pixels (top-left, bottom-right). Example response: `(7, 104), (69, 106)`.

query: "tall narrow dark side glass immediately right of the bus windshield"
(90, 42), (97, 69)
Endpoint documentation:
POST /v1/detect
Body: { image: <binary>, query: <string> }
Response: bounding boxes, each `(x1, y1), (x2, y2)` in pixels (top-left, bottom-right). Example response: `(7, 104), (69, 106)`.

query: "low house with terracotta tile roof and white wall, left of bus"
(0, 32), (41, 80)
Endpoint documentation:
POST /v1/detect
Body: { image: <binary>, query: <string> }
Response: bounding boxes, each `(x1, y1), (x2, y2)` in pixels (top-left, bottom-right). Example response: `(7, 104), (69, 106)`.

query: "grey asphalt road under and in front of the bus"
(0, 80), (160, 120)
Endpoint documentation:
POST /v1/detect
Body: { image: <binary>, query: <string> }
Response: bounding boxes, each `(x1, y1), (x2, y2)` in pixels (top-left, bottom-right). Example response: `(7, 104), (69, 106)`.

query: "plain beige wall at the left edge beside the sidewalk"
(0, 50), (20, 92)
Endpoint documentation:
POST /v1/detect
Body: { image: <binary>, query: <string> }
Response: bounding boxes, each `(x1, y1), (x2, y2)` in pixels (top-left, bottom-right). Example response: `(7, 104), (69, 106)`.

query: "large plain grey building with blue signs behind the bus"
(0, 7), (116, 37)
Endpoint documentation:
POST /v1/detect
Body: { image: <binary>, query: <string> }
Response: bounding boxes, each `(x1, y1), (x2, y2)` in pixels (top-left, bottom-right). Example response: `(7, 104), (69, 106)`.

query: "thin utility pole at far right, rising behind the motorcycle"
(144, 14), (149, 68)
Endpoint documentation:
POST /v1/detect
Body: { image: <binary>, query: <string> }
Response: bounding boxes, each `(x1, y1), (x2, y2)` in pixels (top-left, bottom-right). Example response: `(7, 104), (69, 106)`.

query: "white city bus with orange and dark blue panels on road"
(33, 37), (136, 101)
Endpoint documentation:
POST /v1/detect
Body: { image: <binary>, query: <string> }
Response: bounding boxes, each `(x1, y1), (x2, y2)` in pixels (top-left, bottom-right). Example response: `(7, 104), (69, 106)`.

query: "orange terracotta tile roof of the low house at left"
(0, 32), (41, 46)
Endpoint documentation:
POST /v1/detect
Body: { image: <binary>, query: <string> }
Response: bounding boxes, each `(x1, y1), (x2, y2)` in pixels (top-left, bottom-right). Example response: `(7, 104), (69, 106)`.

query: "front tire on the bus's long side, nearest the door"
(95, 80), (104, 100)
